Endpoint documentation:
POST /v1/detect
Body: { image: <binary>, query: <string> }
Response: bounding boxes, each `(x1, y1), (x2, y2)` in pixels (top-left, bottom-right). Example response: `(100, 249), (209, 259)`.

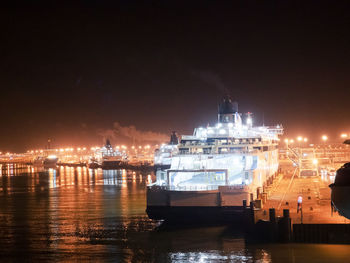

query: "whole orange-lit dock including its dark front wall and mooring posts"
(246, 163), (350, 244)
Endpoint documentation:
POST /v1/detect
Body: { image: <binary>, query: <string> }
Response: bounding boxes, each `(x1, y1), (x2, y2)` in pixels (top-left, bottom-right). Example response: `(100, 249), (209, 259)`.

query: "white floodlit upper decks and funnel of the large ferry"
(152, 99), (283, 190)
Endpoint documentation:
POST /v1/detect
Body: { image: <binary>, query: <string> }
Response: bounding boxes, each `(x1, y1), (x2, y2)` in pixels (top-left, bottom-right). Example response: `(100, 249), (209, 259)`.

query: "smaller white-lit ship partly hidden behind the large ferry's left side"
(154, 131), (179, 171)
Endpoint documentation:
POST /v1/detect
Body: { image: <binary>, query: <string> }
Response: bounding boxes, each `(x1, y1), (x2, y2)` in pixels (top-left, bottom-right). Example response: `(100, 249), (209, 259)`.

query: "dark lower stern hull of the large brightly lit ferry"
(146, 186), (250, 224)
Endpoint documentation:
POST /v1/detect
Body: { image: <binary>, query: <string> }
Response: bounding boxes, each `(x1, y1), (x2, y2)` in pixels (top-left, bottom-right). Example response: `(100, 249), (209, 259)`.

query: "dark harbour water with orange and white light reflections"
(0, 165), (350, 263)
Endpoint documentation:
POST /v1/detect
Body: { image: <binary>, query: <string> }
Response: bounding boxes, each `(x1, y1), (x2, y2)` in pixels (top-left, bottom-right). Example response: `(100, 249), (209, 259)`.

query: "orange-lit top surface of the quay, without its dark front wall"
(256, 164), (350, 224)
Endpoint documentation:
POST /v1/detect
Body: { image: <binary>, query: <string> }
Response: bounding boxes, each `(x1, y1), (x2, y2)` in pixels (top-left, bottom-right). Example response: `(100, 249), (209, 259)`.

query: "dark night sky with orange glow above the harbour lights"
(0, 1), (350, 151)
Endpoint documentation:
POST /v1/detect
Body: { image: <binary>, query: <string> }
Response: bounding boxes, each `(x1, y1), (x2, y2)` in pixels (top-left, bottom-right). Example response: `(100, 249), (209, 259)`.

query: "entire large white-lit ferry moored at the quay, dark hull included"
(146, 97), (283, 223)
